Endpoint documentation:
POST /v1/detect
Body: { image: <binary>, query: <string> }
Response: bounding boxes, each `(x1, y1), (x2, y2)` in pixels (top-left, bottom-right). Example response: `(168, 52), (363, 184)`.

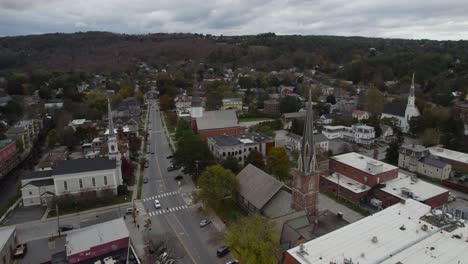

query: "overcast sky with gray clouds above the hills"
(0, 0), (468, 40)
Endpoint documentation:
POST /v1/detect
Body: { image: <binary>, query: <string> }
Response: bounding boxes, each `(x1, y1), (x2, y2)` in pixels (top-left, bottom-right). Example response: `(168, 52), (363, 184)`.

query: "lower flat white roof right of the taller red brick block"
(381, 173), (448, 202)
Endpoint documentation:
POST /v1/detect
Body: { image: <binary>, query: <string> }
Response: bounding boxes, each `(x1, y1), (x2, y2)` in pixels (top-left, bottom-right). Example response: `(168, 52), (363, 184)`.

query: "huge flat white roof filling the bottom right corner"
(288, 199), (468, 264)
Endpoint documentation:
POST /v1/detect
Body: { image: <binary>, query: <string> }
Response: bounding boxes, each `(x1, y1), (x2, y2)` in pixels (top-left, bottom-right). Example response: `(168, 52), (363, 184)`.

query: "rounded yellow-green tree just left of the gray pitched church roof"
(197, 165), (240, 210)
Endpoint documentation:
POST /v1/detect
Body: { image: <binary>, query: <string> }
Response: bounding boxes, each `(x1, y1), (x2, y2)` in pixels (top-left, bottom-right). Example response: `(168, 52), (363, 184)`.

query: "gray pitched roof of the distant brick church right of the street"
(197, 110), (239, 130)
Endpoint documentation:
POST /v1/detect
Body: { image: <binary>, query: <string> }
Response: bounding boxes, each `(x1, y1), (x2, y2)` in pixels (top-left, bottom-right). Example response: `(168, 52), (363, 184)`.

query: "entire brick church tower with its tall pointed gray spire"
(291, 90), (320, 217)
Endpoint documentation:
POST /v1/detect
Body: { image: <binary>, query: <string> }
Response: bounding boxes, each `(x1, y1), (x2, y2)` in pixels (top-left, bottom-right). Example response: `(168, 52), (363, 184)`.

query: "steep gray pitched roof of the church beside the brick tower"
(237, 164), (283, 209)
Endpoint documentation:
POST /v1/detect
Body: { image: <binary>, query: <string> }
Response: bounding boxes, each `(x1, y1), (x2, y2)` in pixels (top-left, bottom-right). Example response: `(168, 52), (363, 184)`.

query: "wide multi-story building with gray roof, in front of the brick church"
(207, 133), (275, 164)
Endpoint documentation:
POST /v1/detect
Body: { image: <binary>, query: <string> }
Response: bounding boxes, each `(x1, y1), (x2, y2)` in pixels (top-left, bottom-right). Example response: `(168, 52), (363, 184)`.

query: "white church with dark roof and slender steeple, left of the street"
(21, 99), (123, 206)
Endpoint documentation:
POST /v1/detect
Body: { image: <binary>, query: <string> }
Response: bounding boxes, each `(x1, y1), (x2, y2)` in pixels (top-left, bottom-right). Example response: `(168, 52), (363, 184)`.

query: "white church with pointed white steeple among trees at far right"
(381, 73), (421, 133)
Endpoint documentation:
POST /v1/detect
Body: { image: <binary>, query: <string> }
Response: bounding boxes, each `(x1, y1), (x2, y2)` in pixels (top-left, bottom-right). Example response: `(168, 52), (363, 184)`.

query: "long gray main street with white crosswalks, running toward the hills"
(142, 101), (228, 263)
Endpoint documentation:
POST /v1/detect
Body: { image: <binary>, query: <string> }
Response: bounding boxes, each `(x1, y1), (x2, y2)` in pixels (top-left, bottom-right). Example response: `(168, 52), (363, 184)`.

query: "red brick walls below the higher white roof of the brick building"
(330, 159), (398, 187)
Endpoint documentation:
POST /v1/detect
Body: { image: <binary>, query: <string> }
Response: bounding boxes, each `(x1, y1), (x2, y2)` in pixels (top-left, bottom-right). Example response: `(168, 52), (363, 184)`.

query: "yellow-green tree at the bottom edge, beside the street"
(224, 214), (281, 264)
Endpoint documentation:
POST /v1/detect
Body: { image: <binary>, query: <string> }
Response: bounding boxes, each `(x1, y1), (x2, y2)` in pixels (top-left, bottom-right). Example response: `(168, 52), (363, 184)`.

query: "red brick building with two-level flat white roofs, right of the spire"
(320, 152), (448, 207)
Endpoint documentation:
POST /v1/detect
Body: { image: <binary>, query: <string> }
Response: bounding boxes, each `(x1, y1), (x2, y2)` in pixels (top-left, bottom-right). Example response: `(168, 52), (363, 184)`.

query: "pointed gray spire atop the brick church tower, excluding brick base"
(298, 89), (318, 175)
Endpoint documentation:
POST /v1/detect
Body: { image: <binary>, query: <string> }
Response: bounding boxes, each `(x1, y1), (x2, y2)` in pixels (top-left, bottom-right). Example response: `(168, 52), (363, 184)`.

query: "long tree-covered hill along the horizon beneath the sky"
(0, 32), (468, 104)
